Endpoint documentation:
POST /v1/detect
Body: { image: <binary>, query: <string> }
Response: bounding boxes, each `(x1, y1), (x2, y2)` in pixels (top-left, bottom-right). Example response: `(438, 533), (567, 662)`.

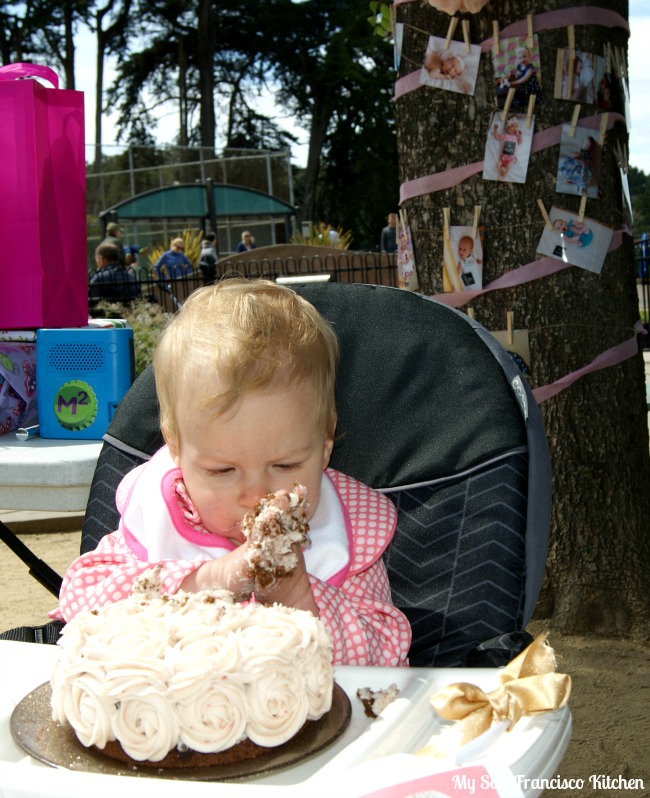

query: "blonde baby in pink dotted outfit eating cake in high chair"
(55, 279), (411, 666)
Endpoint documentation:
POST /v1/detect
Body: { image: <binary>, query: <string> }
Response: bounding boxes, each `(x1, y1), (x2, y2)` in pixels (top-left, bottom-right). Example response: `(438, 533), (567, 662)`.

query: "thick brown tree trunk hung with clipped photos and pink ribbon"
(396, 0), (650, 638)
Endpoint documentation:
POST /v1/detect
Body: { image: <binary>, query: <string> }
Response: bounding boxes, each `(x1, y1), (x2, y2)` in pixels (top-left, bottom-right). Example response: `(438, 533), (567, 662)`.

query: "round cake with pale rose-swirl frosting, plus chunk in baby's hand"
(50, 486), (334, 767)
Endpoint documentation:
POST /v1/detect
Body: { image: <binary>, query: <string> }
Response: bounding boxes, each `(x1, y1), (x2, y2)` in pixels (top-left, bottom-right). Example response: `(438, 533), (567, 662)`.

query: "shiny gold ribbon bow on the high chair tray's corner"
(418, 635), (571, 756)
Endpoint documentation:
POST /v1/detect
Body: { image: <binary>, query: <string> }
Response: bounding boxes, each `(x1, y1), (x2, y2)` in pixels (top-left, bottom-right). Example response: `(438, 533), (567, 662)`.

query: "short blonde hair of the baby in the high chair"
(153, 279), (339, 446)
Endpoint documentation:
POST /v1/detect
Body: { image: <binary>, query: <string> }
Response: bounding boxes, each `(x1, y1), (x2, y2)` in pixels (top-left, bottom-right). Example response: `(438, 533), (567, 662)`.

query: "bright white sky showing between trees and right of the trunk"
(76, 0), (650, 174)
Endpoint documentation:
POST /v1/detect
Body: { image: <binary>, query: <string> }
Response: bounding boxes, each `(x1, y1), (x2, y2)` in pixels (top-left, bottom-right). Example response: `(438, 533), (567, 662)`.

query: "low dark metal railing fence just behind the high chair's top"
(88, 251), (398, 314)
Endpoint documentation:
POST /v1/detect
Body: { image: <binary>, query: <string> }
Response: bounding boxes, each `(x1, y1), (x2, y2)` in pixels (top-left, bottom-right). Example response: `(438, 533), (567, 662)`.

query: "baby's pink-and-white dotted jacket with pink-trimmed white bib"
(50, 447), (411, 666)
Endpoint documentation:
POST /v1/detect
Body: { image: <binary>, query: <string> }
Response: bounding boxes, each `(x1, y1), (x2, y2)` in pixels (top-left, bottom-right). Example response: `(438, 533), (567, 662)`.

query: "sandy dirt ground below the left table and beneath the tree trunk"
(0, 532), (650, 798)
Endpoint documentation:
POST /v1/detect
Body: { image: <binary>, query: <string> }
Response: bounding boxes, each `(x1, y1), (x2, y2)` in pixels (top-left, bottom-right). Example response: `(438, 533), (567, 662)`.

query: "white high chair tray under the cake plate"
(0, 641), (571, 798)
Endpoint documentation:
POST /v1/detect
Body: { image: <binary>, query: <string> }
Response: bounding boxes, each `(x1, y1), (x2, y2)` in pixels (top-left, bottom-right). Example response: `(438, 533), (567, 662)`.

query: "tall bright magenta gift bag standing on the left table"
(0, 63), (88, 329)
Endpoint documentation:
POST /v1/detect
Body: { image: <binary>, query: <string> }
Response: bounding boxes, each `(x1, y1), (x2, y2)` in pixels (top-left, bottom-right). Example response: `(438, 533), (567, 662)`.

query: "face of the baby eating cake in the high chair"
(170, 385), (333, 543)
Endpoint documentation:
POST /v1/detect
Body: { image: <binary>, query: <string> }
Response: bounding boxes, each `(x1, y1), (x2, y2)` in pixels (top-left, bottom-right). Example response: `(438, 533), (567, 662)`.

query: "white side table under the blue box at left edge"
(0, 432), (102, 512)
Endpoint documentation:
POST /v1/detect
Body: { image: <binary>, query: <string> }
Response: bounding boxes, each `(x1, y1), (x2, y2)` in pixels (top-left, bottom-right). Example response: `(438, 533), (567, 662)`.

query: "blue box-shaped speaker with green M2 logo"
(36, 327), (135, 440)
